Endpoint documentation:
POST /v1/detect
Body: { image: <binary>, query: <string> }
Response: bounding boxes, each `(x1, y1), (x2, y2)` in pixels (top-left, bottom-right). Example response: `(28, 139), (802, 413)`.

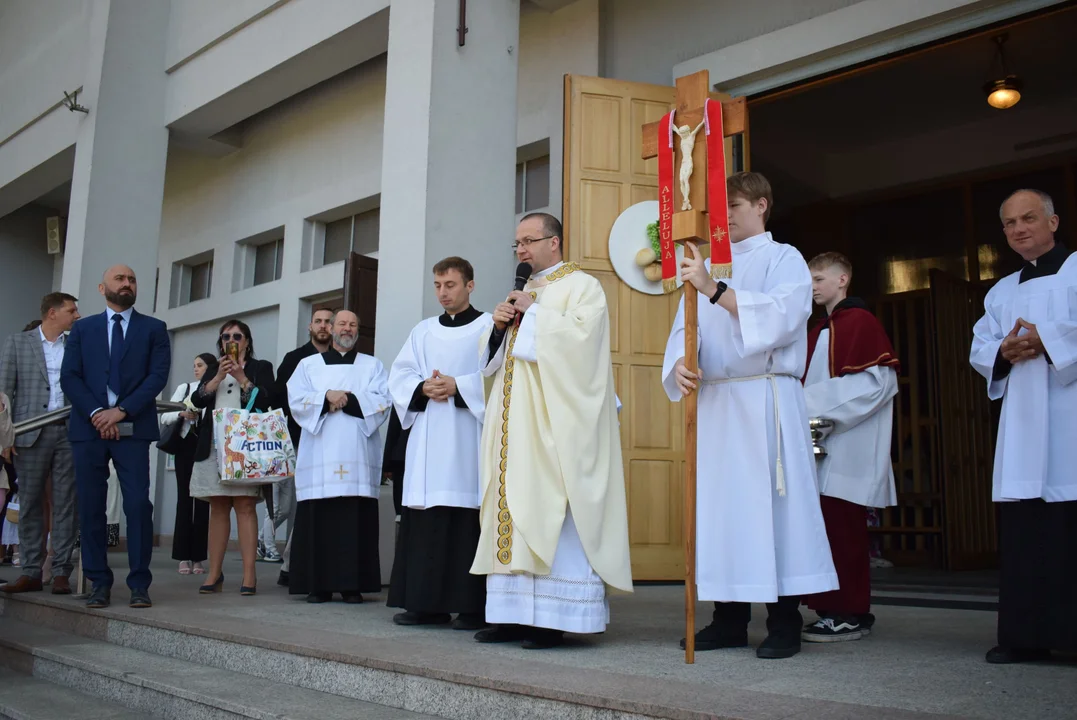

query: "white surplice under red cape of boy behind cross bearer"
(805, 328), (897, 508)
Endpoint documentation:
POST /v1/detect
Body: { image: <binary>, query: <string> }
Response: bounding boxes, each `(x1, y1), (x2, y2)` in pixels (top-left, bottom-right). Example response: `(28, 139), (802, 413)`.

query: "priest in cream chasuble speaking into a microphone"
(472, 213), (632, 648)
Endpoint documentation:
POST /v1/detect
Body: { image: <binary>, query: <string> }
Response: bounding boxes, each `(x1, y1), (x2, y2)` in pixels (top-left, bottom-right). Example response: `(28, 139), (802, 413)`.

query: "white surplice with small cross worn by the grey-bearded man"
(288, 351), (392, 503)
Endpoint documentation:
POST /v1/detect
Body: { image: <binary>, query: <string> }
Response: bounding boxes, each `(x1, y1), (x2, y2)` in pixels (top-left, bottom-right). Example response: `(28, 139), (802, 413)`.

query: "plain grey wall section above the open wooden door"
(599, 0), (859, 85)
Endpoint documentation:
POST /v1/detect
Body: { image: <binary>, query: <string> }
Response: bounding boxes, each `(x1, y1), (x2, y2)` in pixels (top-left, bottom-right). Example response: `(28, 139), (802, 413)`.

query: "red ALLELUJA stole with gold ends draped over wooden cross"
(658, 99), (733, 293)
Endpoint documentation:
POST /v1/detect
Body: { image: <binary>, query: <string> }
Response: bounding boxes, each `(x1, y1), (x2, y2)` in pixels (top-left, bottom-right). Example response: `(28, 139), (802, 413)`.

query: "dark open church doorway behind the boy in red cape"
(750, 4), (1077, 569)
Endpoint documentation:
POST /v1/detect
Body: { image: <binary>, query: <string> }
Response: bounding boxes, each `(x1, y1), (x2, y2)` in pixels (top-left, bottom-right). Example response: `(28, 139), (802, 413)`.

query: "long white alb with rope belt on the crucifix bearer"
(662, 232), (838, 603)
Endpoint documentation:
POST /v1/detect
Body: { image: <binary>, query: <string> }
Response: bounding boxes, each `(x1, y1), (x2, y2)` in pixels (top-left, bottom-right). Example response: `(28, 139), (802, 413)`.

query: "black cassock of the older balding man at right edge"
(994, 243), (1077, 652)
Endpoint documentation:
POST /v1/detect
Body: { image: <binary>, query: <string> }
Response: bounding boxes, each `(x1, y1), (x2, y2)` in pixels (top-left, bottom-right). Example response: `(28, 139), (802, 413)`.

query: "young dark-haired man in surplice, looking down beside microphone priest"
(388, 257), (493, 630)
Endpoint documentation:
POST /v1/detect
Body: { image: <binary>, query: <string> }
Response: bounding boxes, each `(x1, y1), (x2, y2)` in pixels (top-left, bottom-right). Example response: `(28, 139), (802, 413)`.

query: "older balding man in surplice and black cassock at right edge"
(969, 190), (1077, 663)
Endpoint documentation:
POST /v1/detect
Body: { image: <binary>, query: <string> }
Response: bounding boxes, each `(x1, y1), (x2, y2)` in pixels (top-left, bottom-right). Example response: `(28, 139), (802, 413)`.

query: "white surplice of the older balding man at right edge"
(969, 255), (1077, 503)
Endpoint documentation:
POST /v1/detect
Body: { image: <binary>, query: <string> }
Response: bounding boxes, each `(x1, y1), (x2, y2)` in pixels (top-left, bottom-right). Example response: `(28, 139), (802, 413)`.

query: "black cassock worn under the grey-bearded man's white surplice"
(288, 348), (381, 595)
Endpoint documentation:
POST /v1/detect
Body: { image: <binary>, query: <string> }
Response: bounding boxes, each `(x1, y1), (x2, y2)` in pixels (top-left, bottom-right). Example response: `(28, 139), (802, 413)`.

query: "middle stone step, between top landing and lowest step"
(0, 618), (434, 720)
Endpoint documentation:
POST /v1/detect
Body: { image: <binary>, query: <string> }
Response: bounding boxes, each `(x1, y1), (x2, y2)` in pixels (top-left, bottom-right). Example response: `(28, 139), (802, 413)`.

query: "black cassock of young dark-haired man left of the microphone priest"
(387, 308), (486, 616)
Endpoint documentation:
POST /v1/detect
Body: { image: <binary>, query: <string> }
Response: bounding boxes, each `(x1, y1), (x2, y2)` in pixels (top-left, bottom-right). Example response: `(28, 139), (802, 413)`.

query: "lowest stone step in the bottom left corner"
(0, 669), (160, 720)
